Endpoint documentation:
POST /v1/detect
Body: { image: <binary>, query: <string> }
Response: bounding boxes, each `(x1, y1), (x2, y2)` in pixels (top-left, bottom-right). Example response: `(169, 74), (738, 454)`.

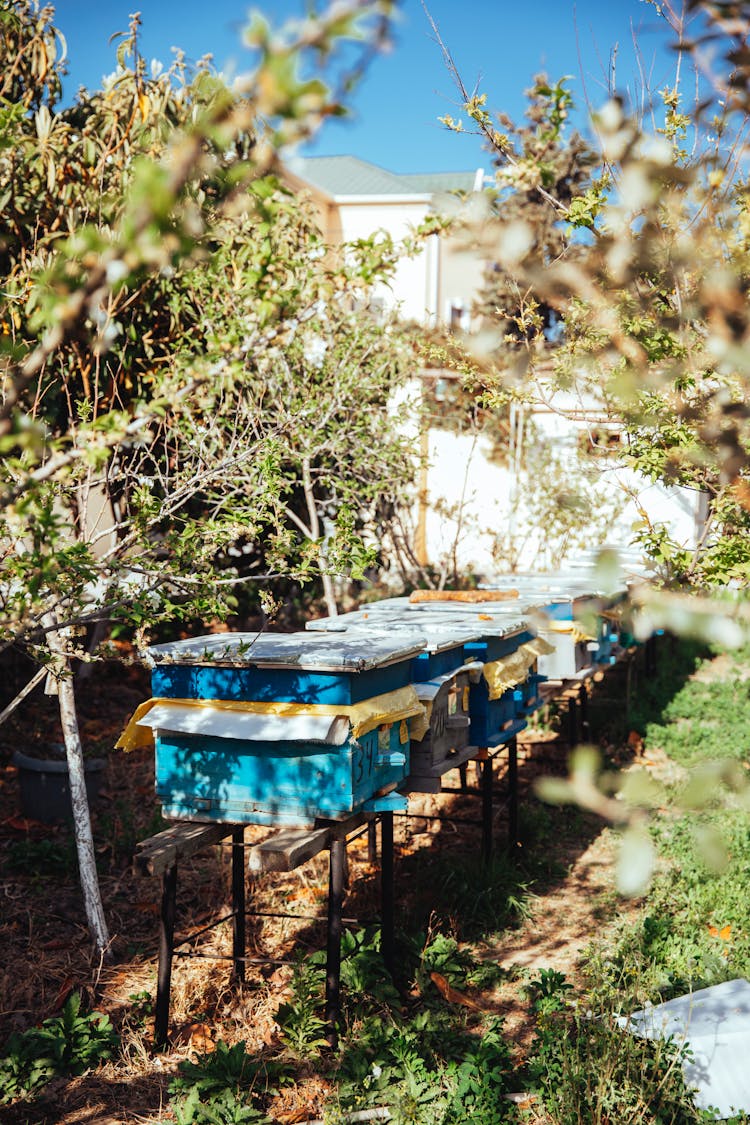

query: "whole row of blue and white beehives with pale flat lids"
(120, 578), (634, 826)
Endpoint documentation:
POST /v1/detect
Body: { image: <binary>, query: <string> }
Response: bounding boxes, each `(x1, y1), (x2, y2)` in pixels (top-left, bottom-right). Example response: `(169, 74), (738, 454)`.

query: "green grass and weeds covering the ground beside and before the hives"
(0, 641), (750, 1125)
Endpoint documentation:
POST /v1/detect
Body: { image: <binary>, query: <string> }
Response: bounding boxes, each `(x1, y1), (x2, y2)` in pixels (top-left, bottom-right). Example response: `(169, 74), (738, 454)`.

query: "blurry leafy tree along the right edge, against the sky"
(431, 0), (750, 636)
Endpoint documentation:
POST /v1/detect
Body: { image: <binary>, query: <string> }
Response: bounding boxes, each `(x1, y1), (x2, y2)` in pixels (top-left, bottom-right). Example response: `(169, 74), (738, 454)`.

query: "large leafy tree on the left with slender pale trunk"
(0, 0), (408, 955)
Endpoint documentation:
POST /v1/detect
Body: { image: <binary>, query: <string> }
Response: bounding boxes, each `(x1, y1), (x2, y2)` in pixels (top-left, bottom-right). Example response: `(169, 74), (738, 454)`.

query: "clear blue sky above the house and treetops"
(55, 0), (692, 172)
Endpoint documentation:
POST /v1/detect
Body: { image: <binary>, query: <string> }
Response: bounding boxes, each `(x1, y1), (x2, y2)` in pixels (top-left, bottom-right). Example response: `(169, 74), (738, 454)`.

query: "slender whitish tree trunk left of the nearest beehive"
(48, 632), (109, 959)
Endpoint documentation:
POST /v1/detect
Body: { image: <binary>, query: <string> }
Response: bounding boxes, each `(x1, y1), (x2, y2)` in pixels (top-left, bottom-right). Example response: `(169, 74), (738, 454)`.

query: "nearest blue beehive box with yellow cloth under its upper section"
(139, 633), (423, 827)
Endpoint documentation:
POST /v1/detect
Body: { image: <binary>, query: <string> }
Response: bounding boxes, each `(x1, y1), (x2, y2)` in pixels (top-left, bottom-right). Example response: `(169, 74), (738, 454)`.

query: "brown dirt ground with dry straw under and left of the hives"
(0, 665), (647, 1125)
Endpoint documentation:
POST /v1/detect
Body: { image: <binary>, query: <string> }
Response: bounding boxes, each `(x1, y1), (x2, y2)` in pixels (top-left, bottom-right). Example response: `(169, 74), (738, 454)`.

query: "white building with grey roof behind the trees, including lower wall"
(288, 155), (702, 581)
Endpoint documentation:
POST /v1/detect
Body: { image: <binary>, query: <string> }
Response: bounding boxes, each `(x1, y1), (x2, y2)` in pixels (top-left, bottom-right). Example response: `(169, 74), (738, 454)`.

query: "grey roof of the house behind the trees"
(291, 156), (475, 196)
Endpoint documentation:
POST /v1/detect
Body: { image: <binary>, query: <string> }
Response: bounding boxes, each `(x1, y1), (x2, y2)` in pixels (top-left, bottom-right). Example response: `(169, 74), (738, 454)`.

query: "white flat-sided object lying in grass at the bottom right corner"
(623, 979), (750, 1118)
